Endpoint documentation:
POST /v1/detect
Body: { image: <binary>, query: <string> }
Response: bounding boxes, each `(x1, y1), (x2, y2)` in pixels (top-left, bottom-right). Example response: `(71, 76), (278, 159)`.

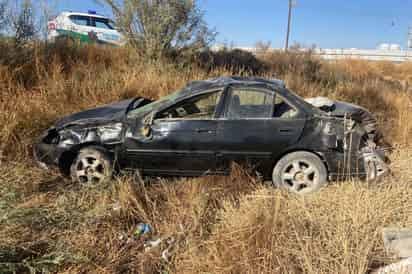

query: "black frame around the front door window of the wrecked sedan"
(153, 88), (226, 122)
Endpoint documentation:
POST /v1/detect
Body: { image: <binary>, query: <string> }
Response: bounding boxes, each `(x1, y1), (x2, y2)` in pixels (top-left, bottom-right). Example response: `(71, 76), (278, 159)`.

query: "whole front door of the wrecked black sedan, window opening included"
(125, 90), (222, 175)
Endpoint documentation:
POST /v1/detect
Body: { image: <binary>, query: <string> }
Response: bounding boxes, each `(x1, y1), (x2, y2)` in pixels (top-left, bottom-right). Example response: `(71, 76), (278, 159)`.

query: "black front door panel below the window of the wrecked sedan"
(123, 120), (217, 174)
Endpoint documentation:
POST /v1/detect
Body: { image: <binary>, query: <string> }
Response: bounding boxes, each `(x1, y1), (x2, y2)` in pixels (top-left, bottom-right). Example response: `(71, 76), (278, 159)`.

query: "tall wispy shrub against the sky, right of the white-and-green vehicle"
(99, 0), (215, 59)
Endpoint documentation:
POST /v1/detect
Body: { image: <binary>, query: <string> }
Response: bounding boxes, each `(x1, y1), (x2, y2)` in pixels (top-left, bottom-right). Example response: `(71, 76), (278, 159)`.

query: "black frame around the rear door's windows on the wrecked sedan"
(221, 85), (305, 121)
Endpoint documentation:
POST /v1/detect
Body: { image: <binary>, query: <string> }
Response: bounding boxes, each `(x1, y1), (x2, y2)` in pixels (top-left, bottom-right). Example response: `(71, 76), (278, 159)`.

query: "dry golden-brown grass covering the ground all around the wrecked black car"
(0, 44), (412, 273)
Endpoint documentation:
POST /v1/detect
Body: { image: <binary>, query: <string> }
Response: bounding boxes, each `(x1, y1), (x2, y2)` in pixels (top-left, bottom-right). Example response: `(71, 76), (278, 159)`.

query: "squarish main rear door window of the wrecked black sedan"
(225, 89), (274, 119)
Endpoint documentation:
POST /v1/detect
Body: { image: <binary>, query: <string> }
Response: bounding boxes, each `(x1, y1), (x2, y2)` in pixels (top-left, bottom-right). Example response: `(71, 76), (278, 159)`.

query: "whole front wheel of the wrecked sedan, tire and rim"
(70, 147), (113, 186)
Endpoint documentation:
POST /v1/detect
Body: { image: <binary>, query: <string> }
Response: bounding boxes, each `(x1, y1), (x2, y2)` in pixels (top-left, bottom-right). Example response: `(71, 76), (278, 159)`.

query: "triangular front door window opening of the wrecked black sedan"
(156, 91), (222, 119)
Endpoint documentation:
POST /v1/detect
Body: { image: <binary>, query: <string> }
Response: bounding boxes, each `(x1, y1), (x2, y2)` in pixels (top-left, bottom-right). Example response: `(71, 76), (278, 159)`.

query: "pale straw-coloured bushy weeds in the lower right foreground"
(176, 179), (412, 273)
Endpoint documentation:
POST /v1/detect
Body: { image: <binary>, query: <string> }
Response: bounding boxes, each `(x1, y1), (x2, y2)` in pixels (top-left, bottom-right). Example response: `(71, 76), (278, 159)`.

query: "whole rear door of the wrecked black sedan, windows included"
(216, 86), (305, 170)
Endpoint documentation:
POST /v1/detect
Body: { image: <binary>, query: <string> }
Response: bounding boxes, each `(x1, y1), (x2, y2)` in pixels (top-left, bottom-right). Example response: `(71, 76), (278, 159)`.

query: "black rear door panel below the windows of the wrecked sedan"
(216, 118), (305, 169)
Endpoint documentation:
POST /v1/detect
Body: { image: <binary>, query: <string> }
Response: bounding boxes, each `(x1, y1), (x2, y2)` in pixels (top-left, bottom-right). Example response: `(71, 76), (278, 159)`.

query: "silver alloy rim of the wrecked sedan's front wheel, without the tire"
(76, 155), (106, 185)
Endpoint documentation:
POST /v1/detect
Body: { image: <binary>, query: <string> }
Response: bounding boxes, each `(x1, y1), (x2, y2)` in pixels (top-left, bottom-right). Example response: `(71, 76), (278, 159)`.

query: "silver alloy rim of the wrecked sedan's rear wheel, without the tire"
(282, 160), (319, 193)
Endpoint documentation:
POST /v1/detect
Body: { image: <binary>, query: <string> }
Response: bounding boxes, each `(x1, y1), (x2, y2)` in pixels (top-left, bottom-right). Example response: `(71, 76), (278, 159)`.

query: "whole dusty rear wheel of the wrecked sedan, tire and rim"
(272, 151), (328, 195)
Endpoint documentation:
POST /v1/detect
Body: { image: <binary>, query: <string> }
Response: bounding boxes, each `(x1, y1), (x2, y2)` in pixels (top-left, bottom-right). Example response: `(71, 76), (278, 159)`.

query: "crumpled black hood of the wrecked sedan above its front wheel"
(54, 99), (135, 129)
